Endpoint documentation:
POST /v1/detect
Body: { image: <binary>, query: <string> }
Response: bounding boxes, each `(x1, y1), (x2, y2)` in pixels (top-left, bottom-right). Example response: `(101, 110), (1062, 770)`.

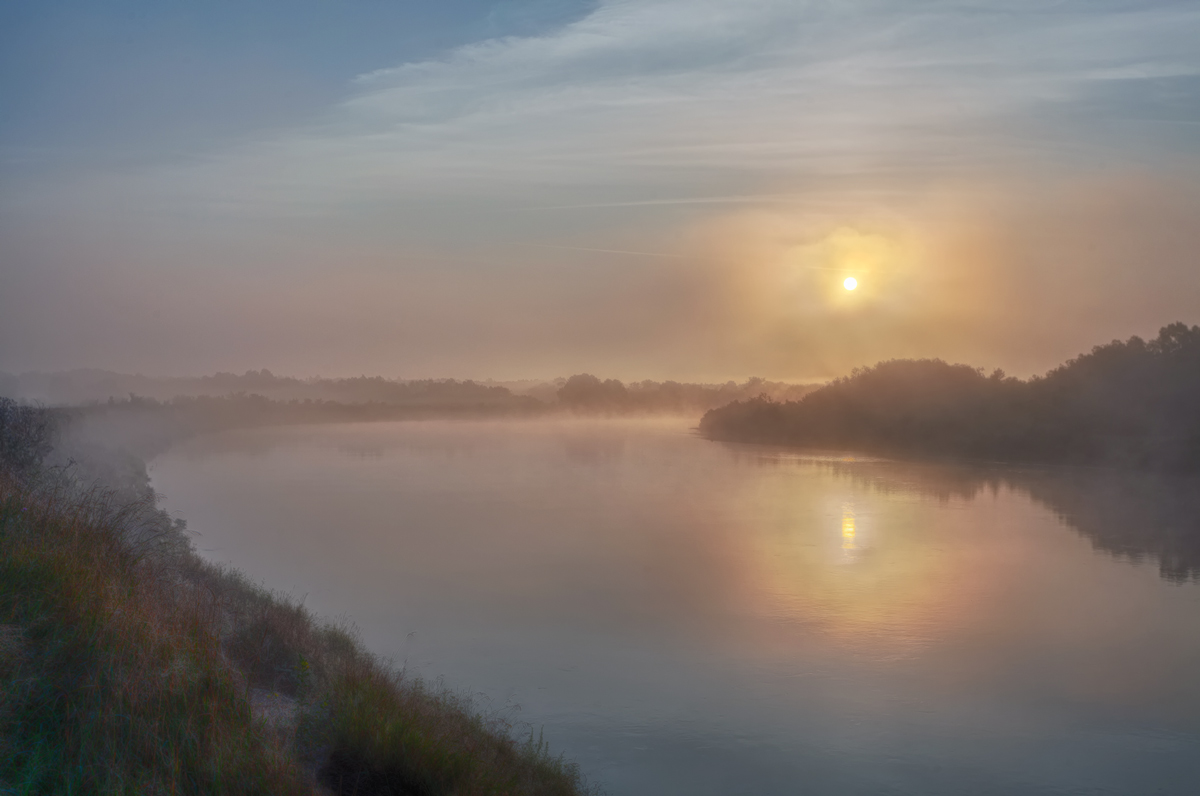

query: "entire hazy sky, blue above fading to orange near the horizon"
(0, 0), (1200, 381)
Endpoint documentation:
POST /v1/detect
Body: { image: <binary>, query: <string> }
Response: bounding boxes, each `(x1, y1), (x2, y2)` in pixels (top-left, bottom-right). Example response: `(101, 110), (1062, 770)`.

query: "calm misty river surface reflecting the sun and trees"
(151, 421), (1200, 796)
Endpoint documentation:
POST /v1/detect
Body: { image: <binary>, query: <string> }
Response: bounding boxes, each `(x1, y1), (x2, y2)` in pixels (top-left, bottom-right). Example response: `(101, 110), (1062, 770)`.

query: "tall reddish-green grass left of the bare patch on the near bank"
(0, 481), (312, 794)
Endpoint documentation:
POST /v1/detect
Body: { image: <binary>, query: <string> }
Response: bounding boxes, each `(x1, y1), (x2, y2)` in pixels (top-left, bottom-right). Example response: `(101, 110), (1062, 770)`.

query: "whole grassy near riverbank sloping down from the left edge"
(0, 407), (584, 796)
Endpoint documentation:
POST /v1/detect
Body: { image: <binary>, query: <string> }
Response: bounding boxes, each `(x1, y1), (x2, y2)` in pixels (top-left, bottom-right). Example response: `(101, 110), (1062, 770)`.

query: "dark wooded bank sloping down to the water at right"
(700, 323), (1200, 471)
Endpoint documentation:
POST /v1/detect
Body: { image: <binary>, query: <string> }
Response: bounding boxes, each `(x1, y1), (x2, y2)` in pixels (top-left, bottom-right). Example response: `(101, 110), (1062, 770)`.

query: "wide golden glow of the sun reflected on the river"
(749, 468), (986, 660)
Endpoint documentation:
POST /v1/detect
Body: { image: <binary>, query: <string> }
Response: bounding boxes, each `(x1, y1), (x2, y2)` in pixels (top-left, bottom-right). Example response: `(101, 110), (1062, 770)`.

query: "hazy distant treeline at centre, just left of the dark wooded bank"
(557, 373), (816, 414)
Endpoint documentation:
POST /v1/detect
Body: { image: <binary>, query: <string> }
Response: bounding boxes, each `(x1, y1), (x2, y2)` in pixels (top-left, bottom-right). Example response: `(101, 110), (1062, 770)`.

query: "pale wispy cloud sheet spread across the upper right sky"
(79, 0), (1200, 218)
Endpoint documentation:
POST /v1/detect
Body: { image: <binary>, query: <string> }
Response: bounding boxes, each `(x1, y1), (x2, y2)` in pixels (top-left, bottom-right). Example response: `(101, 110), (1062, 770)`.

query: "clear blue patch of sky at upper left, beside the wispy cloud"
(0, 0), (589, 167)
